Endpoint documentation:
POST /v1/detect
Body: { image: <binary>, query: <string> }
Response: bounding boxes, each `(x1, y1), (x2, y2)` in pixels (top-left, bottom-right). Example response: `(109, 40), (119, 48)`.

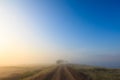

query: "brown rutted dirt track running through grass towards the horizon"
(25, 65), (91, 80)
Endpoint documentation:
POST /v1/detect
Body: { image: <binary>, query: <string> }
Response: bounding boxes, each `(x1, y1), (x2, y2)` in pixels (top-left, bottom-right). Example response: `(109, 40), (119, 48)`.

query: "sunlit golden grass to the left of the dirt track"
(0, 65), (53, 80)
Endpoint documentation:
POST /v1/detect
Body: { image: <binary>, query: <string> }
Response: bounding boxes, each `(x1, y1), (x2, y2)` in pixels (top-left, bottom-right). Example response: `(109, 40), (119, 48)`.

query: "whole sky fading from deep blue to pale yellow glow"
(0, 0), (120, 67)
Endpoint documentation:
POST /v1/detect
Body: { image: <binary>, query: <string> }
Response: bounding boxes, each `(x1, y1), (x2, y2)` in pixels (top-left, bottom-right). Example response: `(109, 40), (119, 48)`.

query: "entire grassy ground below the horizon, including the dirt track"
(0, 65), (120, 80)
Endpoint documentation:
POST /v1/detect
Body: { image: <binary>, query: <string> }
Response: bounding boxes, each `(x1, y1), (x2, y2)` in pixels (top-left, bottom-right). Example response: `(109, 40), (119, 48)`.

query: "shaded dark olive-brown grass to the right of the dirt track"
(72, 65), (120, 80)
